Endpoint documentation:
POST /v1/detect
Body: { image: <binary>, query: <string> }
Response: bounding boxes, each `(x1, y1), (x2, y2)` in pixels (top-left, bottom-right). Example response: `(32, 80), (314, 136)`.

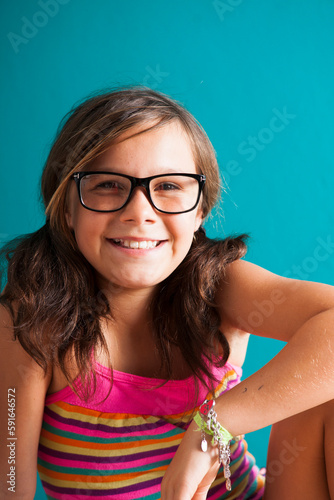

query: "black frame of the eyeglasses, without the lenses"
(72, 170), (206, 215)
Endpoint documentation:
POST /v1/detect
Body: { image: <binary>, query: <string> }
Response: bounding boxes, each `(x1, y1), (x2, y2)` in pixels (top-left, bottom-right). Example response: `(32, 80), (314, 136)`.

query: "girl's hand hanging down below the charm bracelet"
(161, 422), (219, 500)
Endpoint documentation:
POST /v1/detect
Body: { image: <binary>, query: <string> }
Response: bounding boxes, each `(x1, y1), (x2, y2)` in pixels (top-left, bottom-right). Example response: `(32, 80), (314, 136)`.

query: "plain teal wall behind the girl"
(0, 0), (334, 499)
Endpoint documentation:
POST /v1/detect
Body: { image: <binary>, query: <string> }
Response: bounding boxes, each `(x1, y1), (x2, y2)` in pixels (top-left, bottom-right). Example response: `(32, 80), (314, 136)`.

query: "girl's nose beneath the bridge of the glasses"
(120, 187), (157, 224)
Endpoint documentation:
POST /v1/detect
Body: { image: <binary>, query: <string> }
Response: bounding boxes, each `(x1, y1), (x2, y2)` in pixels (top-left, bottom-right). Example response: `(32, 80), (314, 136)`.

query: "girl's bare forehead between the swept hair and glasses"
(88, 121), (196, 177)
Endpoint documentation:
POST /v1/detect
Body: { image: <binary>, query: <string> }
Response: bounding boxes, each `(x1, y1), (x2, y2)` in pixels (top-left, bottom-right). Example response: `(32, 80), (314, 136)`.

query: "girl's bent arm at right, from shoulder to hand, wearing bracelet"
(162, 261), (334, 500)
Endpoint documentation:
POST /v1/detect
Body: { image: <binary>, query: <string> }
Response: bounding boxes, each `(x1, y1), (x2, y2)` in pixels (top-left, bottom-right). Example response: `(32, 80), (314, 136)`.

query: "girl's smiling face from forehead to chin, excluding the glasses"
(67, 122), (202, 289)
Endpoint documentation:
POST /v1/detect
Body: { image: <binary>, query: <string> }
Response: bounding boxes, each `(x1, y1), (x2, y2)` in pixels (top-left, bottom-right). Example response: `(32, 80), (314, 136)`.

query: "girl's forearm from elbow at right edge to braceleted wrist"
(216, 309), (334, 435)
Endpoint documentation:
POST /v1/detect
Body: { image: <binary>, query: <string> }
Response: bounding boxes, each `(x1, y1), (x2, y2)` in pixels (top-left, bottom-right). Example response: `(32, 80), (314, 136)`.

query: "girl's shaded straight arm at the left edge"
(0, 307), (50, 500)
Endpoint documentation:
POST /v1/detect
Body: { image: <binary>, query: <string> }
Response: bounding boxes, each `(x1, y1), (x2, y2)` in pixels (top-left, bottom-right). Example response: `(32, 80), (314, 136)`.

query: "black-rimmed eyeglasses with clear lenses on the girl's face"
(73, 172), (205, 214)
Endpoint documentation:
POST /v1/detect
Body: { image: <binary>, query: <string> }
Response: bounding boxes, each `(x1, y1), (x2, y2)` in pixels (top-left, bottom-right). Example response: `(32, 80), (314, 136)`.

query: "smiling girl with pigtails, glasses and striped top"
(0, 88), (334, 500)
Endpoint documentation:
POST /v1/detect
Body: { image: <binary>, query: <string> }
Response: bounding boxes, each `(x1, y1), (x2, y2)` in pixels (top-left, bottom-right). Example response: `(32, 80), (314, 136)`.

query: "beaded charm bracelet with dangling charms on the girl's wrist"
(194, 399), (233, 491)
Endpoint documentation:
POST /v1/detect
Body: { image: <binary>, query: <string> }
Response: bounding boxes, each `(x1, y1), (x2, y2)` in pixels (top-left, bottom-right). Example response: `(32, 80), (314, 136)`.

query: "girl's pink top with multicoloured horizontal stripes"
(38, 363), (264, 500)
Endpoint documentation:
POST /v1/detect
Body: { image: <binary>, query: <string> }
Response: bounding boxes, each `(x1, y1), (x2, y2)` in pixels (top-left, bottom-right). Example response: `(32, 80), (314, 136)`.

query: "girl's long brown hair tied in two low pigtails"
(0, 87), (246, 398)
